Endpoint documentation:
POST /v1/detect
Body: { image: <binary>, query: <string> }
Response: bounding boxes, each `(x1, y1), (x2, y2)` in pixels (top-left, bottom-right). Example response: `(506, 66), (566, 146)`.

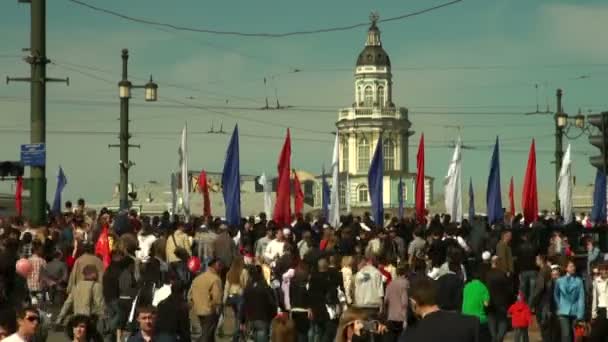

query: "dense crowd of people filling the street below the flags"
(0, 200), (608, 342)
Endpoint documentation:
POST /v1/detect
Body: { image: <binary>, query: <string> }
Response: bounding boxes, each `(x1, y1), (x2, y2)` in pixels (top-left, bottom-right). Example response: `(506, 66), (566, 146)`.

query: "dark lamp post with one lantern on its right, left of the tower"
(110, 49), (158, 210)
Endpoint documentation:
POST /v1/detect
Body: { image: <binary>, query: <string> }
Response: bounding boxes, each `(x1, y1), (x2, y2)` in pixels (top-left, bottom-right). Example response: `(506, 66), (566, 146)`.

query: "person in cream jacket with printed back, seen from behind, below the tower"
(354, 258), (384, 310)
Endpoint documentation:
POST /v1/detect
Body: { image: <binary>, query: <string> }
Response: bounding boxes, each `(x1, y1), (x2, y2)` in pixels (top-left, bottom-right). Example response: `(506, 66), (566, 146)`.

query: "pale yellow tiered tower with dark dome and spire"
(336, 13), (413, 214)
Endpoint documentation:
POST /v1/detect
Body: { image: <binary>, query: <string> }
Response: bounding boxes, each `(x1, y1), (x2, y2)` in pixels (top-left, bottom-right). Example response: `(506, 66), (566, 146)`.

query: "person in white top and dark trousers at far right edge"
(590, 263), (608, 341)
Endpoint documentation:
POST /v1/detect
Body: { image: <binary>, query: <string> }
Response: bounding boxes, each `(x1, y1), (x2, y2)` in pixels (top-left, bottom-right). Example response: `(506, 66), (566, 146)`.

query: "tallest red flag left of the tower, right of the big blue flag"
(273, 128), (291, 227)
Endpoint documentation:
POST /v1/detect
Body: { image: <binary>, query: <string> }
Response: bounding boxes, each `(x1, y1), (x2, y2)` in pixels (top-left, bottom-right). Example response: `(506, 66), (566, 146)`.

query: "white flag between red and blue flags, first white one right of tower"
(444, 137), (462, 222)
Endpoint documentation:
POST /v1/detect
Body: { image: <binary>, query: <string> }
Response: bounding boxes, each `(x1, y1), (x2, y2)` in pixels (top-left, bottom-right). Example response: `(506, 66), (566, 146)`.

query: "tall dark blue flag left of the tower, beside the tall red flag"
(222, 125), (241, 225)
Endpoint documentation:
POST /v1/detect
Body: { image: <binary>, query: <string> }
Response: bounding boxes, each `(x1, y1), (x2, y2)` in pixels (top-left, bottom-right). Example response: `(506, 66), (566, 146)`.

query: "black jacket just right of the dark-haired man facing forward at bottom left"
(156, 293), (190, 342)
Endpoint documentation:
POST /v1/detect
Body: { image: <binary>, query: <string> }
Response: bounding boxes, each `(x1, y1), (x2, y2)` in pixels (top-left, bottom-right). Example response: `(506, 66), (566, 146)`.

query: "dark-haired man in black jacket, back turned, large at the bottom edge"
(399, 277), (479, 342)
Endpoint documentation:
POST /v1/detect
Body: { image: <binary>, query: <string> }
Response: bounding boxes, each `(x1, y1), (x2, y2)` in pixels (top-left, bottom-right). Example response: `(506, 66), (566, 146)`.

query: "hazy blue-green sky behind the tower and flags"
(0, 0), (608, 207)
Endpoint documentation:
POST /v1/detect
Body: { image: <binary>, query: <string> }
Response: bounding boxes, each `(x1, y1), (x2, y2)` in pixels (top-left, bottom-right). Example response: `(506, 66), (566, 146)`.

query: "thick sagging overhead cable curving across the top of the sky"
(68, 0), (463, 38)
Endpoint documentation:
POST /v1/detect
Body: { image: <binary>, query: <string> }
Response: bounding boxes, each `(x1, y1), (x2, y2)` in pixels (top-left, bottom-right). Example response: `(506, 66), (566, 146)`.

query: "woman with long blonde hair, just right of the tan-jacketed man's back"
(224, 256), (249, 342)
